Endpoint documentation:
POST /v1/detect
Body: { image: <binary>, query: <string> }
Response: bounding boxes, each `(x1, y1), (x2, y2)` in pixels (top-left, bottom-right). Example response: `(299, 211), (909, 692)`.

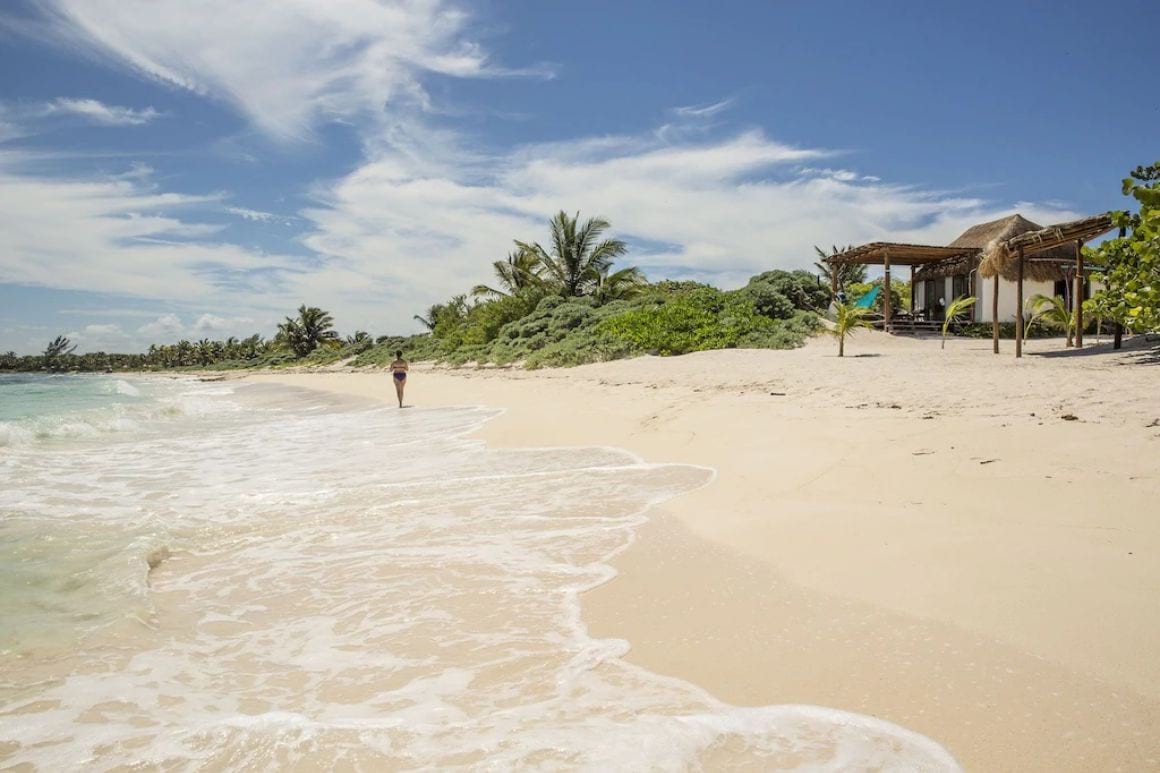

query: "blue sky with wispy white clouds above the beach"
(0, 0), (1160, 353)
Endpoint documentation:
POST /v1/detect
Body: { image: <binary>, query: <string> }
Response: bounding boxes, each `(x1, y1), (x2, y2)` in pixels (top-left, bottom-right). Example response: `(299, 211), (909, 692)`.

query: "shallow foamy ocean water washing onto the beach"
(0, 375), (958, 771)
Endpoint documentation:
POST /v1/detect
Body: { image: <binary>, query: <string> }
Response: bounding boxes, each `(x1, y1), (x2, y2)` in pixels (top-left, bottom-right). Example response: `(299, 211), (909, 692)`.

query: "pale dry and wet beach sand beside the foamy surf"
(240, 332), (1160, 771)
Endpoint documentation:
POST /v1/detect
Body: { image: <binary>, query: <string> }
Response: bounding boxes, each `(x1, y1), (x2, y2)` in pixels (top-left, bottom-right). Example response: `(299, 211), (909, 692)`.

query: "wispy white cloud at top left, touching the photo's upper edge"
(27, 0), (548, 139)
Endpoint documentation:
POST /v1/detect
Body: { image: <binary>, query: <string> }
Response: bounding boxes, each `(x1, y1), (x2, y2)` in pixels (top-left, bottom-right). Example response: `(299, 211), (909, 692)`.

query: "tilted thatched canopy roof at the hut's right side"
(979, 212), (1115, 280)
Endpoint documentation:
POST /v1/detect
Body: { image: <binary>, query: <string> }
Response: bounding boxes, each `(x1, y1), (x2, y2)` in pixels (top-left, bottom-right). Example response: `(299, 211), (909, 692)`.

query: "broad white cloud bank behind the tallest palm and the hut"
(302, 125), (1074, 328)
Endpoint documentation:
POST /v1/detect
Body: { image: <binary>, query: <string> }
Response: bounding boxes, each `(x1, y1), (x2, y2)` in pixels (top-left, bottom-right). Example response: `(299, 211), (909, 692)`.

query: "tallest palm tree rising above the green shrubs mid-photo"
(515, 210), (629, 297)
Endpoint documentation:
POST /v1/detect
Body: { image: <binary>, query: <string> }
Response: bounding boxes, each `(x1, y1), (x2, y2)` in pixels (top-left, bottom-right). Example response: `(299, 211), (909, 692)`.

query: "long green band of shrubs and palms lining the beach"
(0, 211), (844, 371)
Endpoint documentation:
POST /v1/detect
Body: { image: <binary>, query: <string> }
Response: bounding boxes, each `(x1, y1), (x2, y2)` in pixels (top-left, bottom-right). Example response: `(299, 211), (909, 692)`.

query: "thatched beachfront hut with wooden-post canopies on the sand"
(825, 214), (1112, 356)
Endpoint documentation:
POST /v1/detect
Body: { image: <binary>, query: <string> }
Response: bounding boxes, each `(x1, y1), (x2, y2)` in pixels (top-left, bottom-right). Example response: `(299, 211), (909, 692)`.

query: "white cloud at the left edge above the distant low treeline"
(0, 152), (298, 303)
